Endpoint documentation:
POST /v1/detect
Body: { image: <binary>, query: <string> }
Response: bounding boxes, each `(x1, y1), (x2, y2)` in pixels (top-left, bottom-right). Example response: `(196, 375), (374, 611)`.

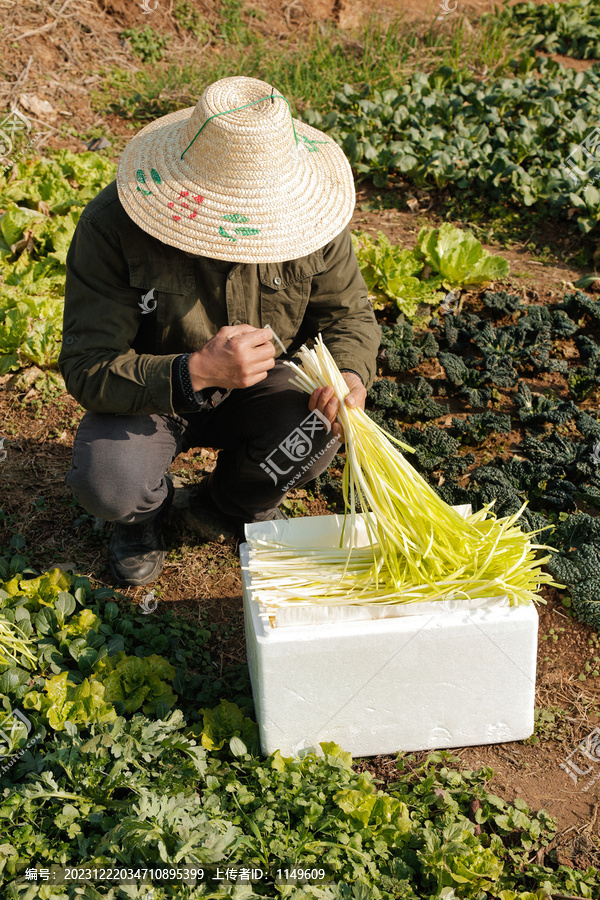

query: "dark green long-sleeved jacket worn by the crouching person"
(59, 182), (380, 414)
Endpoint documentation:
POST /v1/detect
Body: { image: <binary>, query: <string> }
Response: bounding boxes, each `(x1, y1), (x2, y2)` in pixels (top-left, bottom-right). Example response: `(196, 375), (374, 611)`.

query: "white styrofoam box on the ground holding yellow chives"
(240, 517), (538, 756)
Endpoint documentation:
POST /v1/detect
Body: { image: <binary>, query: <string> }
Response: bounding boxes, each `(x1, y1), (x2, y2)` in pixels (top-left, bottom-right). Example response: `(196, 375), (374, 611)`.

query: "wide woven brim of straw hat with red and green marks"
(117, 107), (355, 263)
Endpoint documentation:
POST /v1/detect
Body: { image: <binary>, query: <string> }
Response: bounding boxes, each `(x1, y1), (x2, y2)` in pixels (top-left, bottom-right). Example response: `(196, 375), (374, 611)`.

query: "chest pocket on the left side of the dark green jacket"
(129, 256), (200, 354)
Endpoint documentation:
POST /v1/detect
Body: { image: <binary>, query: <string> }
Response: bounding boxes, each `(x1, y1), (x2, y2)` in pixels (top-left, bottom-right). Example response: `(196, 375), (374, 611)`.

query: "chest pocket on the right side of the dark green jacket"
(258, 252), (325, 344)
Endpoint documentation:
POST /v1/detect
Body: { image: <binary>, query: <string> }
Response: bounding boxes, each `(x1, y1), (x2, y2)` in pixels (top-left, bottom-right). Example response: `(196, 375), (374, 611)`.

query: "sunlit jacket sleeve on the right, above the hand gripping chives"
(304, 228), (381, 388)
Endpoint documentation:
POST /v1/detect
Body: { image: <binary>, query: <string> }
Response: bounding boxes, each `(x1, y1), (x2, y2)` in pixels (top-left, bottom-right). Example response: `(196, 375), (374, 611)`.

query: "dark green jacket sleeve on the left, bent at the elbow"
(58, 215), (177, 415)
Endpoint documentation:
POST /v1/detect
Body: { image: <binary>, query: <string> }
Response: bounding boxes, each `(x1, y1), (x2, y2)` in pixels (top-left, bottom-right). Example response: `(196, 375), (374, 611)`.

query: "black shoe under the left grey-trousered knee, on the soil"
(109, 476), (173, 586)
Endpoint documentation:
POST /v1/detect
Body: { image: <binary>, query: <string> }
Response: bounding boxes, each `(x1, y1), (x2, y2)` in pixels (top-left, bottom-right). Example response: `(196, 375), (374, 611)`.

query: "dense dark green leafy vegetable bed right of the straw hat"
(303, 56), (600, 232)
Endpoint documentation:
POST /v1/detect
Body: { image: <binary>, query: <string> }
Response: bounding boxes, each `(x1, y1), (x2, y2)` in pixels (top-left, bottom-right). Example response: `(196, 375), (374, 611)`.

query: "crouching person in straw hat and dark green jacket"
(59, 77), (380, 585)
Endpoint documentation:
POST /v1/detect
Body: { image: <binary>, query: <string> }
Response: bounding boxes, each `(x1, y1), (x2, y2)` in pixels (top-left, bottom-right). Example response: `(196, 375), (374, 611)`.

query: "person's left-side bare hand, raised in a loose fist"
(189, 325), (275, 391)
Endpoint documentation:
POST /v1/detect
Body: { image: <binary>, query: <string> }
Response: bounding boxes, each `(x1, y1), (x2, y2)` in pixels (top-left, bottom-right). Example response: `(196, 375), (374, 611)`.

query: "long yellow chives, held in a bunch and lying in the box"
(249, 335), (562, 611)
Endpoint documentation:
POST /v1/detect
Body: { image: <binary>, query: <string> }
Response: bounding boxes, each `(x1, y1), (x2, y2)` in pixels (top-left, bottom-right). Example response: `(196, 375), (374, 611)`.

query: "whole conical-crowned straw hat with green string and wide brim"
(117, 77), (355, 263)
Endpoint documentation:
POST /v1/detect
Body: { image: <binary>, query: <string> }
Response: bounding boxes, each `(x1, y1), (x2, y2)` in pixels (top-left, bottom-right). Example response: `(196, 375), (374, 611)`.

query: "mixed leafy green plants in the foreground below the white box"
(0, 537), (600, 900)
